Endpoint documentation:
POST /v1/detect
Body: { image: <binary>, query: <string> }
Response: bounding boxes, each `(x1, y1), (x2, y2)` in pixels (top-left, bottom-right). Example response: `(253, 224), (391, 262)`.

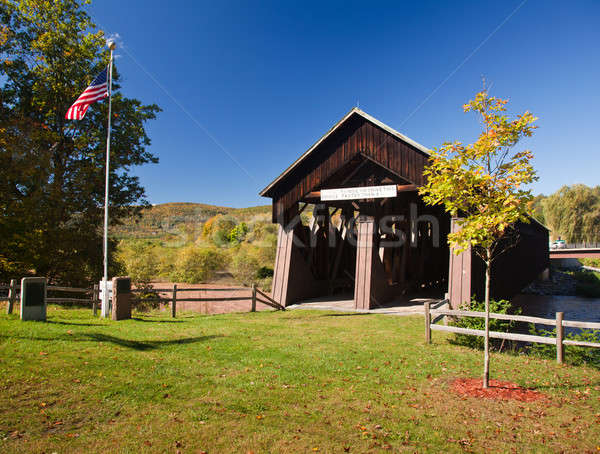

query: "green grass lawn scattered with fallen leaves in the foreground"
(0, 307), (600, 454)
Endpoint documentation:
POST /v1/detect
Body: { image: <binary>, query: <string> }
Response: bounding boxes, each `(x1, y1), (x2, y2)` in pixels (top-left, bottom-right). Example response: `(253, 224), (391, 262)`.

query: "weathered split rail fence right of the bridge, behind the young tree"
(424, 301), (600, 364)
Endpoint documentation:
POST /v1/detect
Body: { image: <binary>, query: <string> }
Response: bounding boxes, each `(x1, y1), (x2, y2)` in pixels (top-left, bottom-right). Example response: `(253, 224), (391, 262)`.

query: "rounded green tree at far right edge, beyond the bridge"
(542, 184), (600, 242)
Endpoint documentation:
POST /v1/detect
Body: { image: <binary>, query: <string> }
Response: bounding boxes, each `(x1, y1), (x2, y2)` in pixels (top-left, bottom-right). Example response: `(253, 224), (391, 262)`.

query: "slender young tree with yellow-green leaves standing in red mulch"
(419, 89), (537, 388)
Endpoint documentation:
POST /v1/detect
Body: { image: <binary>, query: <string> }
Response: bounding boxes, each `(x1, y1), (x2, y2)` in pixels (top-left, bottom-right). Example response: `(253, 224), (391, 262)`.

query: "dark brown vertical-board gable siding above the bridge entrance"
(266, 115), (428, 222)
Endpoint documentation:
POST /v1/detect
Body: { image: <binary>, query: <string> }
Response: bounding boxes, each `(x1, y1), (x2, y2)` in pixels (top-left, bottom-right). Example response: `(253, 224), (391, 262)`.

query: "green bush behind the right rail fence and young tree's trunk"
(452, 300), (521, 350)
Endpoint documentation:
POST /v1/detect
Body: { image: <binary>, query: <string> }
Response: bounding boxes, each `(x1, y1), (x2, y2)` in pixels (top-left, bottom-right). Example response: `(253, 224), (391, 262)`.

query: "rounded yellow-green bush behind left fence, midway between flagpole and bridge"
(171, 246), (226, 284)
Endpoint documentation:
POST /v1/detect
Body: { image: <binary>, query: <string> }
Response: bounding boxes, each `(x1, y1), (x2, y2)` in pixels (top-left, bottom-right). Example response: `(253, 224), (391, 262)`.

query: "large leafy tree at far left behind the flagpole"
(0, 0), (160, 284)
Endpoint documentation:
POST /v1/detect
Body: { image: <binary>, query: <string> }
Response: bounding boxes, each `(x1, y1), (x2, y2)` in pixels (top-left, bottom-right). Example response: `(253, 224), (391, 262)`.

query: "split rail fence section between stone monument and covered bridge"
(132, 284), (285, 317)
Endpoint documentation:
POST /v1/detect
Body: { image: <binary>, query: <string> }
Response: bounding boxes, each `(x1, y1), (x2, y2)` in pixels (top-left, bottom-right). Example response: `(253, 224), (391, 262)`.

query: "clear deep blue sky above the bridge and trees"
(88, 0), (600, 207)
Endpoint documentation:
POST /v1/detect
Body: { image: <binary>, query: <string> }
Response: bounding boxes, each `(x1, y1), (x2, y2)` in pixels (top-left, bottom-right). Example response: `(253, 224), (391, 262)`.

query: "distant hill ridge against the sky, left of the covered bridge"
(113, 203), (271, 239)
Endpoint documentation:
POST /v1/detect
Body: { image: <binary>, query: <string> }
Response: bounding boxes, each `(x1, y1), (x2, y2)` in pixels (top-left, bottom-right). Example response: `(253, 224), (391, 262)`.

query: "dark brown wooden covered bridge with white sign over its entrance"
(260, 108), (549, 309)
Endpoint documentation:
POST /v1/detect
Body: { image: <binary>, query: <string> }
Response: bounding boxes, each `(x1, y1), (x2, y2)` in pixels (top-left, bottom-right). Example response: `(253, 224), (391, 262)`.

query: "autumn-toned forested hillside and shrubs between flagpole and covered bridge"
(111, 203), (277, 290)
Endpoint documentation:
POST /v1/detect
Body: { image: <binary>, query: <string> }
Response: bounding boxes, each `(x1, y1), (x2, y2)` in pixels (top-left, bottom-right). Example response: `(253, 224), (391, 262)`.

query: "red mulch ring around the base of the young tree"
(452, 378), (547, 402)
